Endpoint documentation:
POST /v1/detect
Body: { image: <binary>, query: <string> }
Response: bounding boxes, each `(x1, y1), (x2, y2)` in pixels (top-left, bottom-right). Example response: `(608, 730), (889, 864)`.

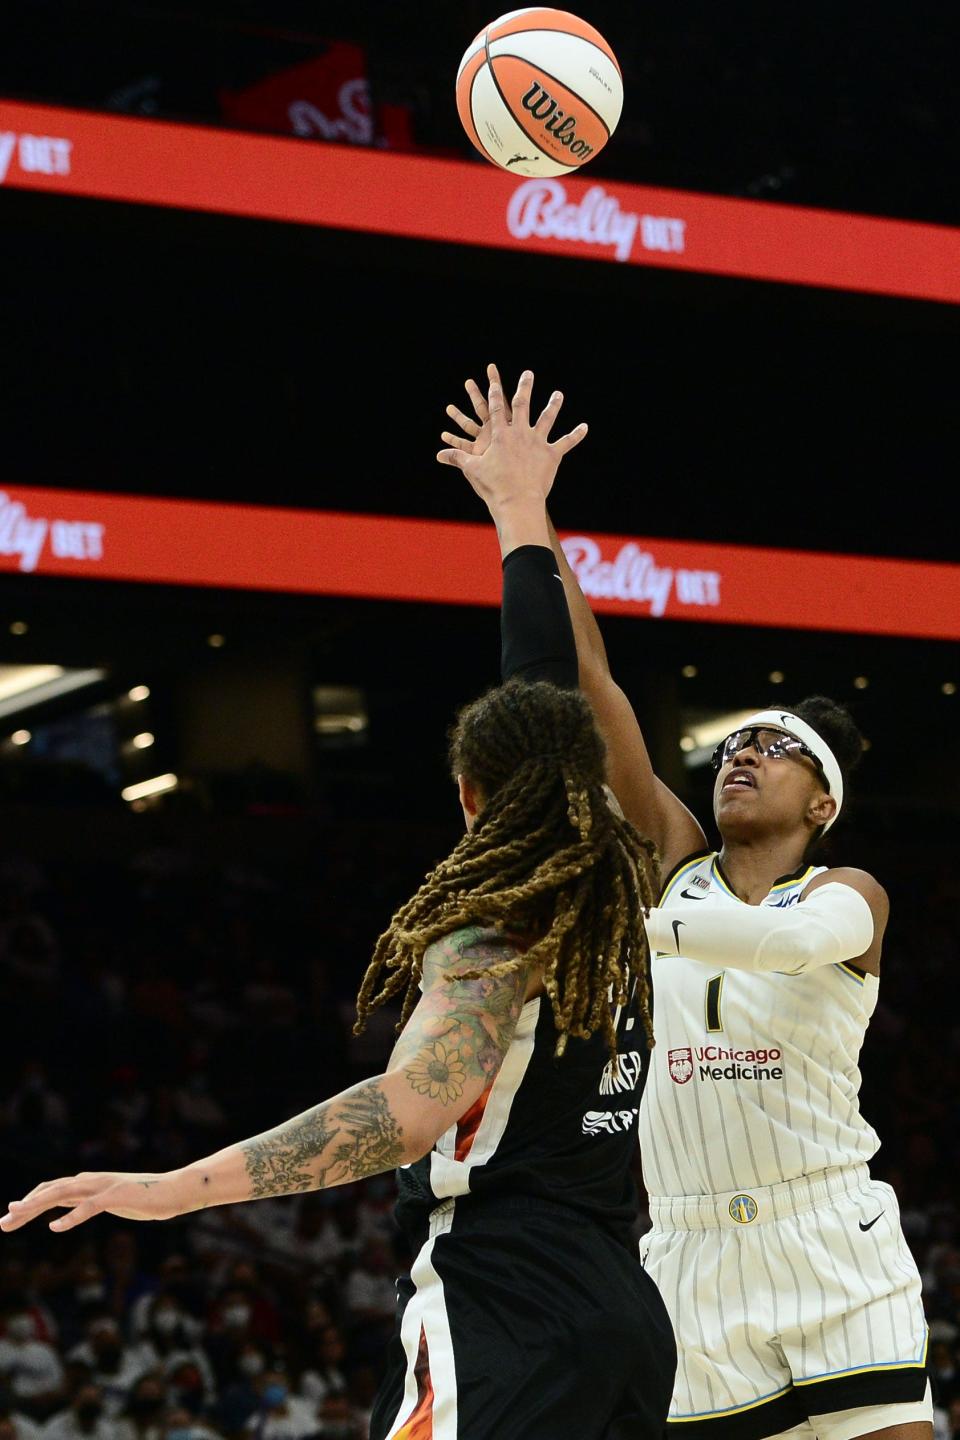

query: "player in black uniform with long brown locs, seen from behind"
(0, 567), (676, 1440)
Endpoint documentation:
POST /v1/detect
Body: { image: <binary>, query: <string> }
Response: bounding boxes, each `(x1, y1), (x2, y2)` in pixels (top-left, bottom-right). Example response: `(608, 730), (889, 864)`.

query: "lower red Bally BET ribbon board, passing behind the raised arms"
(0, 487), (960, 639)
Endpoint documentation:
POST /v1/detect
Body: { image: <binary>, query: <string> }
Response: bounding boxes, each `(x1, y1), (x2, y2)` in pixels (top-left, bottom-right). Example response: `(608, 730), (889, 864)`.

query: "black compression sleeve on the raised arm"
(499, 544), (580, 690)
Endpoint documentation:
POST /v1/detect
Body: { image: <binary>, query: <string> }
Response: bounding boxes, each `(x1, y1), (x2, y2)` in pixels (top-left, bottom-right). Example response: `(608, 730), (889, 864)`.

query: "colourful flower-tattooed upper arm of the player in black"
(391, 929), (527, 1106)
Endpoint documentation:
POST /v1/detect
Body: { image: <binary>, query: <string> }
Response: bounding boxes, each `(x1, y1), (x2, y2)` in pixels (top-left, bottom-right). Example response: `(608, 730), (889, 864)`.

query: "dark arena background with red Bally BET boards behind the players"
(0, 0), (960, 1440)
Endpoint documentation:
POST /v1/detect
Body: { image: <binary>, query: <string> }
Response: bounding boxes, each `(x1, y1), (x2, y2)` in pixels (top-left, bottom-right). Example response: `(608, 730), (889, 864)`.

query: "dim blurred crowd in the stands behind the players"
(0, 816), (960, 1440)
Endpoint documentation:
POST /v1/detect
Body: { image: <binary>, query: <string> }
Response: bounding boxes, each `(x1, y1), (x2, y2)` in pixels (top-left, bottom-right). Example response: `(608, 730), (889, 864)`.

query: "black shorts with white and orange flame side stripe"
(370, 1200), (676, 1440)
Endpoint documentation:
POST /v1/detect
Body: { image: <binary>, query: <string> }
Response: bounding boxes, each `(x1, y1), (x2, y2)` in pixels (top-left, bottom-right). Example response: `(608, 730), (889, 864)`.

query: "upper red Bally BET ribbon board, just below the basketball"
(0, 99), (960, 304)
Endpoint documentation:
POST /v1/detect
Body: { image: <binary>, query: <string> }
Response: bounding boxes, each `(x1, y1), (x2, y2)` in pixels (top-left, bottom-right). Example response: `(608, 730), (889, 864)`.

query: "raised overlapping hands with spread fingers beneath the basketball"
(436, 364), (587, 510)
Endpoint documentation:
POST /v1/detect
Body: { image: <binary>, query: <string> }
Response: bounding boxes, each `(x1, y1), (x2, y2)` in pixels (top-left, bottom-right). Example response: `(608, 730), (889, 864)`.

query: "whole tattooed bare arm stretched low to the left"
(0, 929), (527, 1231)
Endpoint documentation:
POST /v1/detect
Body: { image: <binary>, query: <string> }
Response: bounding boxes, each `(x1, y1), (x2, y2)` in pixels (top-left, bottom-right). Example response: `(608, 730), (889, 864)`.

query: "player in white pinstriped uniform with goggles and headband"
(438, 367), (933, 1440)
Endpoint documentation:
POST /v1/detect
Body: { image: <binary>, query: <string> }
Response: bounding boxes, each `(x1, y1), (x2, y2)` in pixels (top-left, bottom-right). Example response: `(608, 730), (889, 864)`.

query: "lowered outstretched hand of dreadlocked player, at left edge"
(0, 1171), (181, 1234)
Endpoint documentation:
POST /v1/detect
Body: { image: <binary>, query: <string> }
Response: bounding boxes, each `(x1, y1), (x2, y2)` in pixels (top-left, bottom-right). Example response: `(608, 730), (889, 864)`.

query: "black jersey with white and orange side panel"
(397, 932), (646, 1240)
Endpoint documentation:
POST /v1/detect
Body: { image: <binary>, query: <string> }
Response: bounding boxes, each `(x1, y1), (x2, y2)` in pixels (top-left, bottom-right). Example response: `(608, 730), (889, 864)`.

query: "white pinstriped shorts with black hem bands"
(640, 1165), (931, 1440)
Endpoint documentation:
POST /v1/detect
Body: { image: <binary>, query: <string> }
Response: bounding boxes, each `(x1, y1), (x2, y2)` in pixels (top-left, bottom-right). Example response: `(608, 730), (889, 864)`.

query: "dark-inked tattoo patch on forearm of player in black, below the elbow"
(240, 1080), (403, 1200)
